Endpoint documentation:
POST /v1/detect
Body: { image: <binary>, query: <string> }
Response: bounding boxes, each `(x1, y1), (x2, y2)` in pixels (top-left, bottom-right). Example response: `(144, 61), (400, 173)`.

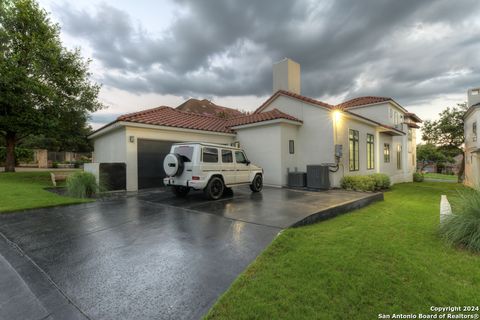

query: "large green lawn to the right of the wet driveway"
(206, 182), (480, 319)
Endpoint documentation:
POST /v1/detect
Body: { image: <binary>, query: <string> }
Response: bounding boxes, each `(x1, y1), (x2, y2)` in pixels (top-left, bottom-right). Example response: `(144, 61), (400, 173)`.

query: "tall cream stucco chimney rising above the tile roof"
(273, 58), (300, 94)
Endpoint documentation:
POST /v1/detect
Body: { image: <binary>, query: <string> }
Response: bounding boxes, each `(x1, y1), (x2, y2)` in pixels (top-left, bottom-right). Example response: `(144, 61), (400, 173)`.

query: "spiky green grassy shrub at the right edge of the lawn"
(439, 189), (480, 252)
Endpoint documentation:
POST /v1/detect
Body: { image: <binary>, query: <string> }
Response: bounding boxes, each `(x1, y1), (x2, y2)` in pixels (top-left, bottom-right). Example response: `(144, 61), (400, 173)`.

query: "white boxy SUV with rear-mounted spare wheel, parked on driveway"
(163, 142), (263, 200)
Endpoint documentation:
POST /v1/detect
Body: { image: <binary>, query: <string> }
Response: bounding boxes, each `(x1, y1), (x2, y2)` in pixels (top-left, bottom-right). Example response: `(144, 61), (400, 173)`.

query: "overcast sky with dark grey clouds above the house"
(39, 0), (480, 127)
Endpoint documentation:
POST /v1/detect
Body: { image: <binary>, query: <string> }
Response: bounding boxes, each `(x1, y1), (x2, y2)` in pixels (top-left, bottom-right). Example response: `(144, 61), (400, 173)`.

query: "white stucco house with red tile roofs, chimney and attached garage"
(86, 59), (421, 190)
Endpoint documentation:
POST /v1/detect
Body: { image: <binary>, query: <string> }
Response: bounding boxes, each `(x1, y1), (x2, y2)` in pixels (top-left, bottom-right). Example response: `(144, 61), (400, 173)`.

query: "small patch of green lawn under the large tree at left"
(0, 172), (92, 213)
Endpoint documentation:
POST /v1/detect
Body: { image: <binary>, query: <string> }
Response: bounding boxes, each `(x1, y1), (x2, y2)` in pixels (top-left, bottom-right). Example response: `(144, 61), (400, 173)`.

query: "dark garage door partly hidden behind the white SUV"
(137, 139), (173, 189)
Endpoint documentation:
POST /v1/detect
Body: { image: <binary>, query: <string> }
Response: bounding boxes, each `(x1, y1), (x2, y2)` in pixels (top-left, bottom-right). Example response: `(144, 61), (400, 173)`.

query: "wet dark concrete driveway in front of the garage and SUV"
(0, 188), (382, 319)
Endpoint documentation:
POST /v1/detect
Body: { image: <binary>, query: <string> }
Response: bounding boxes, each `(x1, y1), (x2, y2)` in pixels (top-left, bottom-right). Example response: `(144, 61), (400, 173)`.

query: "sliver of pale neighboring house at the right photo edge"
(464, 88), (480, 187)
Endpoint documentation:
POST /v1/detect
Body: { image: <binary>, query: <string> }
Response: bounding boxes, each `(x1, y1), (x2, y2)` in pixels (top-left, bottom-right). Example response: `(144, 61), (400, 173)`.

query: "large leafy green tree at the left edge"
(0, 0), (102, 171)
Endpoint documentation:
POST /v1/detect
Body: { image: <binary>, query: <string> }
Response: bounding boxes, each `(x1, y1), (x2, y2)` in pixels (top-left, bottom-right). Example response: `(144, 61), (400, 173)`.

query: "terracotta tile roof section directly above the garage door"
(117, 107), (233, 133)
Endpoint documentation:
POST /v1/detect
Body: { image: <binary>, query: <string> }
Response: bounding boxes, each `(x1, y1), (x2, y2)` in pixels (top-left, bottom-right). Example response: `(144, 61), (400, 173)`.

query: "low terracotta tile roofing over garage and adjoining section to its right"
(111, 107), (302, 133)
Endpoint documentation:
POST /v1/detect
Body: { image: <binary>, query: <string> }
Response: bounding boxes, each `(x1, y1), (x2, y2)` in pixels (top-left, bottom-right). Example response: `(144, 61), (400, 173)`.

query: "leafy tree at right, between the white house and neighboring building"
(422, 103), (467, 182)
